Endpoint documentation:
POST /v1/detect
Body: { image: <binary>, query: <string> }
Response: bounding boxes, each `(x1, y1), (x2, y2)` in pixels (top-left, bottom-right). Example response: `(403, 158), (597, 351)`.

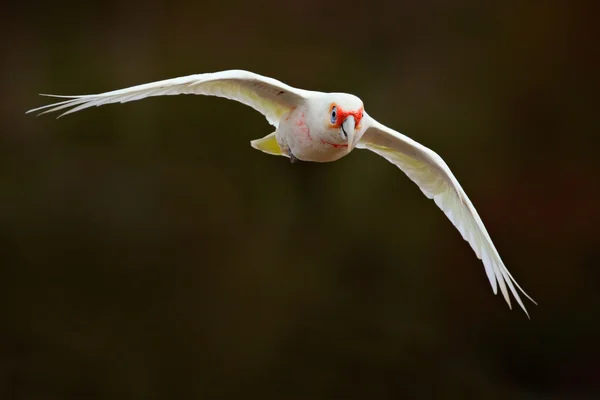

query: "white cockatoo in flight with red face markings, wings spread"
(28, 70), (535, 316)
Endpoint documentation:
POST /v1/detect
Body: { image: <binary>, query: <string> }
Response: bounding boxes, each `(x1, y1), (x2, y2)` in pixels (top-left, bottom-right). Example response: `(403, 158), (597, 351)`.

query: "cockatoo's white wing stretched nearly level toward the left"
(27, 70), (311, 126)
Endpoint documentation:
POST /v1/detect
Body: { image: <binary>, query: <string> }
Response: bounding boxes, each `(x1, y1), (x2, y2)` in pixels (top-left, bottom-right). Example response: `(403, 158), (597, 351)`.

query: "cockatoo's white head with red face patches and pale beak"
(318, 93), (364, 152)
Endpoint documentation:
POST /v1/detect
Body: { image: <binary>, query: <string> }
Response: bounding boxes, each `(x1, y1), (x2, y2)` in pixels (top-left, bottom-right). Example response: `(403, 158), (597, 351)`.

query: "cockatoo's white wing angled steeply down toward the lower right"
(356, 115), (535, 316)
